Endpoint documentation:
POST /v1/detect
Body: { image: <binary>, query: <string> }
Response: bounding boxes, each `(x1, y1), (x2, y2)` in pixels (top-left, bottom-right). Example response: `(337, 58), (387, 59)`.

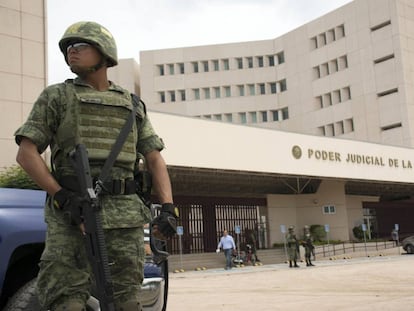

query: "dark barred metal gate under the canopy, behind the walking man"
(168, 197), (266, 254)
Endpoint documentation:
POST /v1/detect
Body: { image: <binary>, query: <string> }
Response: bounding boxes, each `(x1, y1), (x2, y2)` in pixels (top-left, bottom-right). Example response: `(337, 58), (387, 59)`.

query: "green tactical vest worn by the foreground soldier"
(52, 80), (144, 178)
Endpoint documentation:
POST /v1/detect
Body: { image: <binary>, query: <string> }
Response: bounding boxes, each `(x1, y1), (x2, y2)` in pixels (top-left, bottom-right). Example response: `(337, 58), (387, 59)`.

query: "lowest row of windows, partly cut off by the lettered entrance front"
(199, 107), (289, 124)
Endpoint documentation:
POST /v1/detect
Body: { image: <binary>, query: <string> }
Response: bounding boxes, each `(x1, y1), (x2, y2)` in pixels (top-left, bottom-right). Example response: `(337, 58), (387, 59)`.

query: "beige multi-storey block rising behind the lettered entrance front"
(140, 0), (414, 147)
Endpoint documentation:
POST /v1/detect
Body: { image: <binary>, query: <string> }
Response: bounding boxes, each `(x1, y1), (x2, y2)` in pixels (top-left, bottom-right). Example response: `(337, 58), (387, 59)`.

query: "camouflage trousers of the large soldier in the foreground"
(37, 224), (144, 311)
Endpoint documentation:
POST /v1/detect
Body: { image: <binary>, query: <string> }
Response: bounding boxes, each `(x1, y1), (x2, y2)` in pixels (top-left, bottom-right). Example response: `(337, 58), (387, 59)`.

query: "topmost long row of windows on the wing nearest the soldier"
(157, 51), (285, 76)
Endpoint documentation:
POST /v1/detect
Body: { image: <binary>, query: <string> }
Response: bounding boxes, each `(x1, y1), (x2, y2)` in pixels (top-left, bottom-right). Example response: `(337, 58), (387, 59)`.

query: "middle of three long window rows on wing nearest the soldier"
(158, 79), (287, 103)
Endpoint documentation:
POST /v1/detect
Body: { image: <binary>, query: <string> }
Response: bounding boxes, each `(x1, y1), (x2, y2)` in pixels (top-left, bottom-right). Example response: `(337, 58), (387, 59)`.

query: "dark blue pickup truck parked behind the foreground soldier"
(0, 188), (168, 311)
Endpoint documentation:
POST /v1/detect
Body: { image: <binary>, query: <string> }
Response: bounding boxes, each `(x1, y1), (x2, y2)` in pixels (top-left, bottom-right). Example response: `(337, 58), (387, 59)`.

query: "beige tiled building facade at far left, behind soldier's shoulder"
(0, 0), (47, 169)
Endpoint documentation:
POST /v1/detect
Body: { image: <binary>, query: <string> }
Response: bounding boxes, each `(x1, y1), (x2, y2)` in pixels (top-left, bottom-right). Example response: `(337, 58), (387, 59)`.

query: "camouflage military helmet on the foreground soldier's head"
(59, 22), (118, 67)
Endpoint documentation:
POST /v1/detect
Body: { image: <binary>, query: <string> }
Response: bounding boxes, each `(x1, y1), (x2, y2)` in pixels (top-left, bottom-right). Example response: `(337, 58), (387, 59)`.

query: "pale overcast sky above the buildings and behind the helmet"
(47, 0), (351, 84)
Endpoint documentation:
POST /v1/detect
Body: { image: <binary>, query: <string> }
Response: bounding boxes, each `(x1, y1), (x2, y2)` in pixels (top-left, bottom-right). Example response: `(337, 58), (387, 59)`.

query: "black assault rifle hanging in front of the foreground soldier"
(69, 144), (115, 311)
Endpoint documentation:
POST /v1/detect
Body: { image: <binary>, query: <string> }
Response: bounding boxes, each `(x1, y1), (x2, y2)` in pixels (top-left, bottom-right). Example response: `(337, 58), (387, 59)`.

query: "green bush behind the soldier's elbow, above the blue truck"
(0, 165), (40, 189)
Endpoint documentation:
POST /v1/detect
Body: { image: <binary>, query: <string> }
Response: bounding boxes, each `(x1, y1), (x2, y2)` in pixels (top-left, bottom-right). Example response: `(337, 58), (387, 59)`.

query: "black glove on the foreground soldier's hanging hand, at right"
(152, 203), (179, 240)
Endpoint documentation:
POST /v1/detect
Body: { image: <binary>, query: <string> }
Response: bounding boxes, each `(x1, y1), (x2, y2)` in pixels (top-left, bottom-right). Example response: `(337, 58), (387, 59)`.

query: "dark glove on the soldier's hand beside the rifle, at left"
(53, 188), (83, 225)
